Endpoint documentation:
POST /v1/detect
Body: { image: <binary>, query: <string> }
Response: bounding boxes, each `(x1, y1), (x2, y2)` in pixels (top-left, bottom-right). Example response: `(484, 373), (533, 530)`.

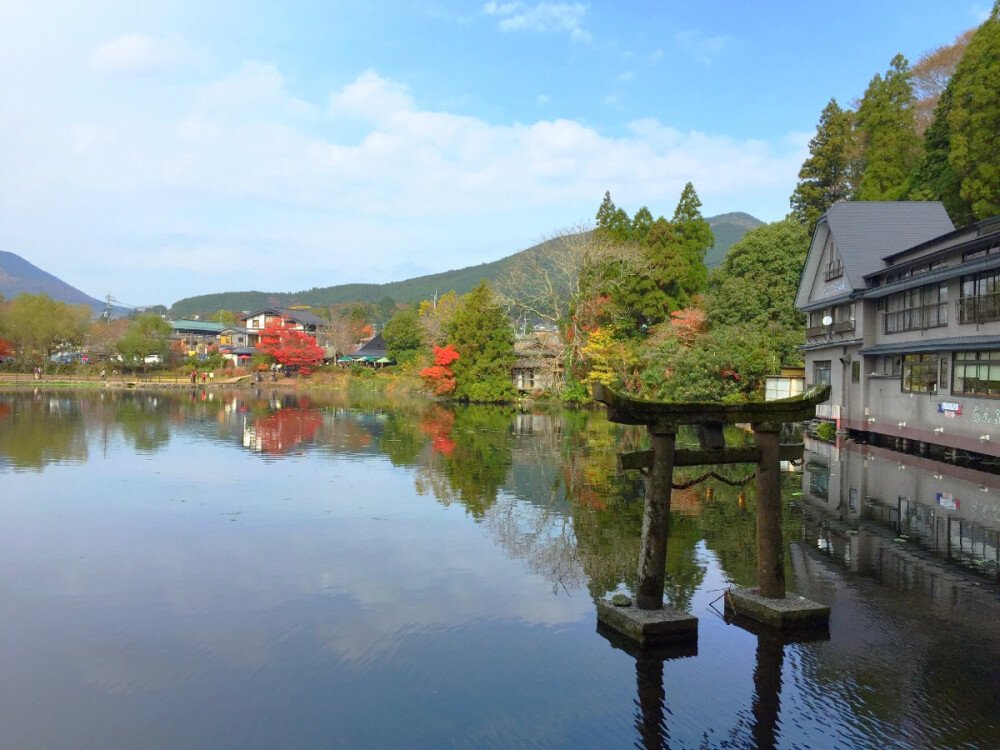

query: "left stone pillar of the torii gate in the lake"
(635, 425), (677, 609)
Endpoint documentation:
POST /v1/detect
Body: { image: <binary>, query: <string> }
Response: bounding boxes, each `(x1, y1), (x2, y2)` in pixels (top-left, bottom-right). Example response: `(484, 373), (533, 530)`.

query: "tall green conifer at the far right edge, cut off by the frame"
(947, 0), (1000, 219)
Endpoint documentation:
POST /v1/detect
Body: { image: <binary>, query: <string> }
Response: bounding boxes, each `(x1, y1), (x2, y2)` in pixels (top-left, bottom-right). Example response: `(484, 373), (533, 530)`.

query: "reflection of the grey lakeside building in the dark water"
(802, 440), (1000, 587)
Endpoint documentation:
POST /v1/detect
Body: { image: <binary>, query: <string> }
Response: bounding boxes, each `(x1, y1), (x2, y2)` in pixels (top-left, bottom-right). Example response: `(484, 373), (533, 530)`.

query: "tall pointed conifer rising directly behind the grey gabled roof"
(857, 55), (920, 200)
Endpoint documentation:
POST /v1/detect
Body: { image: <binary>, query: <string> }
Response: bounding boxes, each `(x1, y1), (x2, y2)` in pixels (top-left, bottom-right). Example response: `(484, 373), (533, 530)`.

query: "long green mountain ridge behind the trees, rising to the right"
(170, 212), (764, 317)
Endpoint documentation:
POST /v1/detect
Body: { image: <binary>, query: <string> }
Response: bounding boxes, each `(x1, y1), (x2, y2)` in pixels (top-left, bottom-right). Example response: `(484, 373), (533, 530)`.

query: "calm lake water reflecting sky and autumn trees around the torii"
(0, 389), (1000, 749)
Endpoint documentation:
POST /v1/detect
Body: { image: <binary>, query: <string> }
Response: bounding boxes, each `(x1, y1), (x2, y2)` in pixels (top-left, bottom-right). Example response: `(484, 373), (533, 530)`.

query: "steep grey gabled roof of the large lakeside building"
(820, 201), (955, 289)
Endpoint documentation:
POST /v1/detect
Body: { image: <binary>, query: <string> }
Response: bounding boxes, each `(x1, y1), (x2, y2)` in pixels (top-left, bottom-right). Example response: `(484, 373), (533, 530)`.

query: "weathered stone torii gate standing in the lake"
(594, 384), (830, 645)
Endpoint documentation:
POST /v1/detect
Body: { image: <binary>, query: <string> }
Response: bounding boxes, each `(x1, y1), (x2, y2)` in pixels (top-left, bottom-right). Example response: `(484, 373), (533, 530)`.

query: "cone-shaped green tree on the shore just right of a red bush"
(446, 280), (514, 402)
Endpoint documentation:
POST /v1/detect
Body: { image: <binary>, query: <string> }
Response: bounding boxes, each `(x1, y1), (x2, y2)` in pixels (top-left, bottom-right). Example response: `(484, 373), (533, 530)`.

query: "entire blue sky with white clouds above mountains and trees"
(0, 0), (991, 305)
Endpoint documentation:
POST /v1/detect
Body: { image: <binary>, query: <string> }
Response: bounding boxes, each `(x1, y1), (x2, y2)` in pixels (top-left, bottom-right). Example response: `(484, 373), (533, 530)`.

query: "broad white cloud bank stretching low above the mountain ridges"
(0, 61), (808, 303)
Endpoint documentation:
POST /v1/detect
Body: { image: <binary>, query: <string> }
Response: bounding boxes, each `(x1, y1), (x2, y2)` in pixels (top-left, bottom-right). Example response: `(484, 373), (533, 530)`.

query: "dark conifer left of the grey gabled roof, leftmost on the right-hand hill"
(789, 99), (856, 234)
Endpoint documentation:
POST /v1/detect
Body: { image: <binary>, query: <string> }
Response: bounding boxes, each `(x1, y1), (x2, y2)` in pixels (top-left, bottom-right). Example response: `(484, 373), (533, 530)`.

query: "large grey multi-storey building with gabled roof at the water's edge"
(795, 201), (1000, 456)
